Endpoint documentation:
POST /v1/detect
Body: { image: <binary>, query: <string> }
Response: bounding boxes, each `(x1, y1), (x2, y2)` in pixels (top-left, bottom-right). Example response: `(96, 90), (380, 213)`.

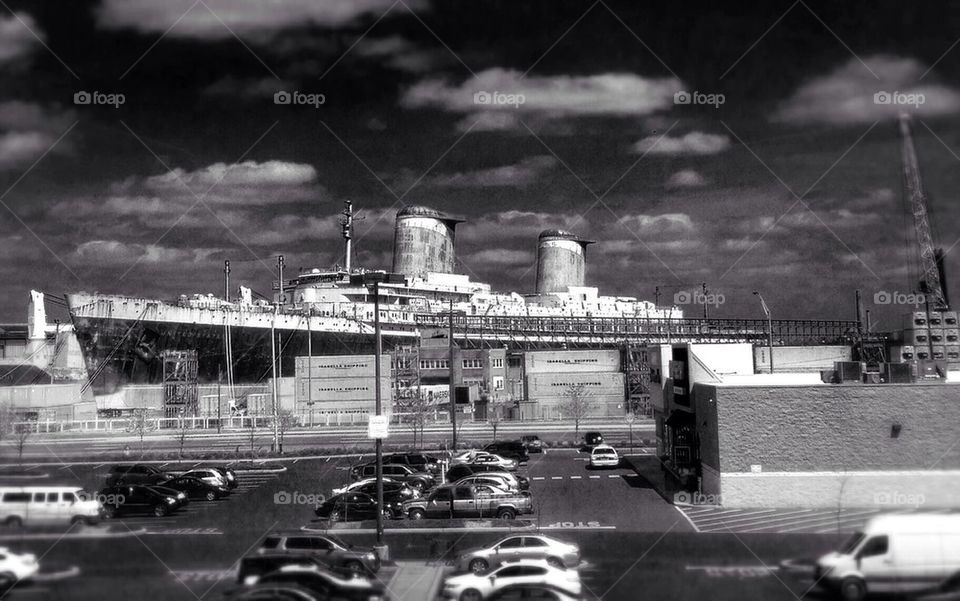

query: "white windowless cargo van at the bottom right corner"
(814, 513), (960, 601)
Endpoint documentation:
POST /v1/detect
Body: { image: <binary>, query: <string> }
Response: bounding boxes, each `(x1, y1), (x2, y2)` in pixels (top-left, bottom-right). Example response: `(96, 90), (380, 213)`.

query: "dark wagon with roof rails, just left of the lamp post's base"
(255, 530), (380, 582)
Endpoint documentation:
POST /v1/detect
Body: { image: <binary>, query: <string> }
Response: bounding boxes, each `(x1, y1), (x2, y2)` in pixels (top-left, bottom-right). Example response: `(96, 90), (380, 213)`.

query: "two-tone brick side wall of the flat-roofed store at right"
(693, 384), (960, 507)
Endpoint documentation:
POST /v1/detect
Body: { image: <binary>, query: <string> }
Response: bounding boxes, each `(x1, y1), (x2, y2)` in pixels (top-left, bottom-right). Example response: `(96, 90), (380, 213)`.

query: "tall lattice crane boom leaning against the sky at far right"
(900, 113), (950, 311)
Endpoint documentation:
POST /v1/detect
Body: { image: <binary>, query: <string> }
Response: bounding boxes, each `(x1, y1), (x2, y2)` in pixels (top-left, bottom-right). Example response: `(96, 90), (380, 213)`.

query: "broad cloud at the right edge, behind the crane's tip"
(771, 55), (960, 125)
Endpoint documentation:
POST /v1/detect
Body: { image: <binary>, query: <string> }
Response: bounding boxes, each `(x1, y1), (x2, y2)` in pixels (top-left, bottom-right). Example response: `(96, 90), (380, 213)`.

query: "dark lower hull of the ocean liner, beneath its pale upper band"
(73, 316), (411, 394)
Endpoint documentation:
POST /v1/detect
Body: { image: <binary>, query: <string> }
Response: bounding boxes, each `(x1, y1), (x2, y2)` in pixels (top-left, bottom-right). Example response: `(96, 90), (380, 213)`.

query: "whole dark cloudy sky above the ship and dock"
(0, 0), (960, 328)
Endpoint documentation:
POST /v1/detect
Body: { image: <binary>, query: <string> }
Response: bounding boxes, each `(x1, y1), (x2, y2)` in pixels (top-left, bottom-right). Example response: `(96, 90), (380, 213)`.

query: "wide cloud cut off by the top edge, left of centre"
(97, 0), (427, 40)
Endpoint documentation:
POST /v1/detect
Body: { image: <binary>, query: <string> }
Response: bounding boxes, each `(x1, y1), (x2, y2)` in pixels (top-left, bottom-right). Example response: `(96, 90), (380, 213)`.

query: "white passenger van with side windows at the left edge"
(0, 485), (101, 526)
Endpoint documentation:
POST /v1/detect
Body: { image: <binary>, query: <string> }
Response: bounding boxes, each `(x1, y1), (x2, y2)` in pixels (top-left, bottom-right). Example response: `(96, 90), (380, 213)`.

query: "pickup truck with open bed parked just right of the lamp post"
(403, 485), (533, 520)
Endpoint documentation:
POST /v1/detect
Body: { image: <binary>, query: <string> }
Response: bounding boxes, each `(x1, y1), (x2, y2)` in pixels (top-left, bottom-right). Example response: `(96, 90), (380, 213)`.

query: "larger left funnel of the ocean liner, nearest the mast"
(393, 206), (463, 277)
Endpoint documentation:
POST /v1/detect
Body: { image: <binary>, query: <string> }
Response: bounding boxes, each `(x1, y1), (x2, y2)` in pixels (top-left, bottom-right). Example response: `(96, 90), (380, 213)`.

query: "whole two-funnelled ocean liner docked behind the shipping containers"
(67, 201), (682, 394)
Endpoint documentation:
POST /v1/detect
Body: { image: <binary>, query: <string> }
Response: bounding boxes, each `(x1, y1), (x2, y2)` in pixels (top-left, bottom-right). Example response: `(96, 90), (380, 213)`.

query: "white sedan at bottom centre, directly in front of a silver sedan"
(442, 559), (582, 601)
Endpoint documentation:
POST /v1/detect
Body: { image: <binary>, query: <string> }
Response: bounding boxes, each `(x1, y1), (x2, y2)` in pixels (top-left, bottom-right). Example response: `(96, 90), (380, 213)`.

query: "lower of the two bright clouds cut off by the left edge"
(0, 100), (72, 170)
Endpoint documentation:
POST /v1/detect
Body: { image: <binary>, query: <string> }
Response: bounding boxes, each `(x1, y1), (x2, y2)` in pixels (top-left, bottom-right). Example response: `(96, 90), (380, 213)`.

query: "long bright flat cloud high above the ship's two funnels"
(401, 68), (681, 117)
